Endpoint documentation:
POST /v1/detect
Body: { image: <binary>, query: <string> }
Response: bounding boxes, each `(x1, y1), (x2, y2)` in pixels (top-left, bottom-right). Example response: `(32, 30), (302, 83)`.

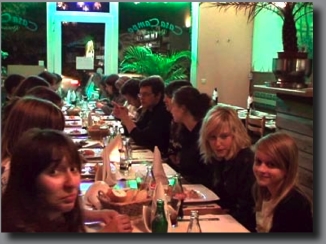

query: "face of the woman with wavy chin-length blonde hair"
(208, 128), (233, 158)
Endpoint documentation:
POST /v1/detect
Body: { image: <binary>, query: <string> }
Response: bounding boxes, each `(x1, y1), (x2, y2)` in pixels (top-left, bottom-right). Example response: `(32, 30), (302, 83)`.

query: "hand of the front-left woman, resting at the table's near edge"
(100, 214), (132, 233)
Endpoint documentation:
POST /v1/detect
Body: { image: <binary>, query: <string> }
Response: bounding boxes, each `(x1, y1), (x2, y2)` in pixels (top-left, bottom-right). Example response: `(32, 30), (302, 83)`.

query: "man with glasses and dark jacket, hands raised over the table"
(113, 76), (172, 157)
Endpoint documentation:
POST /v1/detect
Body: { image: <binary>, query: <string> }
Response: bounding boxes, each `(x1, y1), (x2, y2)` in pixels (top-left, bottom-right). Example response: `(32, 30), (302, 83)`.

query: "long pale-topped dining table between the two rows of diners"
(65, 111), (249, 233)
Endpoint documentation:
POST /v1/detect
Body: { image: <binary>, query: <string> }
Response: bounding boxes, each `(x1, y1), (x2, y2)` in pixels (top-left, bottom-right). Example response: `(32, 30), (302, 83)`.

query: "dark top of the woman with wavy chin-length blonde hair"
(208, 148), (256, 232)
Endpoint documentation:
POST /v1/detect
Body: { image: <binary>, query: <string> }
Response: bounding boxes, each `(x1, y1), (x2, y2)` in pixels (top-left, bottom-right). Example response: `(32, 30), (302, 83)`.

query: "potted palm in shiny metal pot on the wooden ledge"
(211, 2), (313, 88)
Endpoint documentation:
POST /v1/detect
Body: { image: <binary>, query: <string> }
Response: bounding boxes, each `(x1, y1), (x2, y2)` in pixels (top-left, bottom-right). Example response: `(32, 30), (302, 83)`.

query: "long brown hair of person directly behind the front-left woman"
(1, 96), (65, 160)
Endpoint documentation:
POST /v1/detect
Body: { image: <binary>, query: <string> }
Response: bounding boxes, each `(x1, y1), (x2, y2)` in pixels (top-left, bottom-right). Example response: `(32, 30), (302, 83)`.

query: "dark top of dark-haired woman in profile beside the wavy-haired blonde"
(178, 121), (208, 185)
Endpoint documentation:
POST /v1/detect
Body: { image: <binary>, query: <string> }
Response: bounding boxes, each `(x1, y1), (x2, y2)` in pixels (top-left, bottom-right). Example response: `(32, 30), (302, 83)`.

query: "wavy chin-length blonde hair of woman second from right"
(199, 105), (251, 162)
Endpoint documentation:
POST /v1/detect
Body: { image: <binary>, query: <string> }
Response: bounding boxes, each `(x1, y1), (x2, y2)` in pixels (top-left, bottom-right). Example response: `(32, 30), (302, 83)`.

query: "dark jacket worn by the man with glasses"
(129, 101), (172, 157)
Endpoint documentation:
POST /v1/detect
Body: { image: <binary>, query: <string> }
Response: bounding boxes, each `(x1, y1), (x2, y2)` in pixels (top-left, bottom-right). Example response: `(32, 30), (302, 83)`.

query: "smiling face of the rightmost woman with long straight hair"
(253, 150), (285, 192)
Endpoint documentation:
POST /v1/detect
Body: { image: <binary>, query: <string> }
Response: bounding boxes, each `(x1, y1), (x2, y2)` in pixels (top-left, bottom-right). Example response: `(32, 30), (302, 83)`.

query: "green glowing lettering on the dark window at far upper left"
(1, 13), (38, 32)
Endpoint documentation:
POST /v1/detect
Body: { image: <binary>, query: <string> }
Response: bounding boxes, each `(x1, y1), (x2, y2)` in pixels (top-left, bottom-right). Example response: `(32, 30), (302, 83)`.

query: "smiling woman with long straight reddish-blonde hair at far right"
(253, 132), (313, 232)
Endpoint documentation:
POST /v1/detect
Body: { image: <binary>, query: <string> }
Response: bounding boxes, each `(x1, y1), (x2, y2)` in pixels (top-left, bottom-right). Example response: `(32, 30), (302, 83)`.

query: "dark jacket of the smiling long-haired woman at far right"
(270, 189), (313, 232)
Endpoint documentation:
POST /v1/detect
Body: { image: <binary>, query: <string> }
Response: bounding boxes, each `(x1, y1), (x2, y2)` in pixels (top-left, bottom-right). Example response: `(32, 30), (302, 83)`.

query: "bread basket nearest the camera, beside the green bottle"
(98, 188), (152, 217)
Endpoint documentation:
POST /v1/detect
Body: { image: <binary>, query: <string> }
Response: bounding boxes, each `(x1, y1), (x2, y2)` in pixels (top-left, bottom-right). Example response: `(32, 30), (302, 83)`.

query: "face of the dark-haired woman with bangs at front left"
(36, 158), (80, 219)
